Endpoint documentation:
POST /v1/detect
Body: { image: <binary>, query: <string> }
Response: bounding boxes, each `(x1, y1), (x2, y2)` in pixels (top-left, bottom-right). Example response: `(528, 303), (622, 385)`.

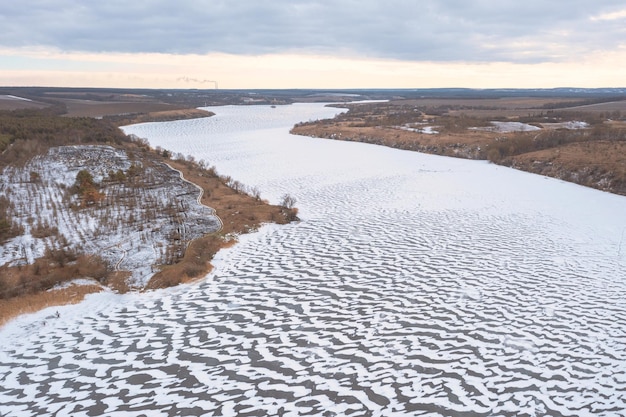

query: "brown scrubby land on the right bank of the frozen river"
(292, 98), (626, 195)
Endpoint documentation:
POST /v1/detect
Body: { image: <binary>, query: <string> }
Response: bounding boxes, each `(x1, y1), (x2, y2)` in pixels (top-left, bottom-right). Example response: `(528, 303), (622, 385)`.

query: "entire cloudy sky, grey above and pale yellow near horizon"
(0, 0), (626, 88)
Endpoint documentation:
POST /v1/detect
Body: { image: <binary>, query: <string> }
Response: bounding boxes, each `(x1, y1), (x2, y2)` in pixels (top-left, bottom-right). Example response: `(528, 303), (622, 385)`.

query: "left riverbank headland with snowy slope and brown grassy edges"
(0, 113), (297, 325)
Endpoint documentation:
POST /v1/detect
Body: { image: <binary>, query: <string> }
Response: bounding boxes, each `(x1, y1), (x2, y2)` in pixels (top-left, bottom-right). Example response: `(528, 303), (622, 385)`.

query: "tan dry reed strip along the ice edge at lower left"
(0, 284), (103, 326)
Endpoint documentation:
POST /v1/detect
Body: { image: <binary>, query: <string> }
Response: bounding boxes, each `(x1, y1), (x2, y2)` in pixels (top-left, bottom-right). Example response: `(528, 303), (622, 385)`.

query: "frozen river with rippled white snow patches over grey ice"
(0, 104), (626, 416)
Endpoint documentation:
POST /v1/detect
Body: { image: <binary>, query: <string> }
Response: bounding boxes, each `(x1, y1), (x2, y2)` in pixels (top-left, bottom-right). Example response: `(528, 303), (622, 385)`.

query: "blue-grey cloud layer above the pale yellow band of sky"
(0, 0), (626, 61)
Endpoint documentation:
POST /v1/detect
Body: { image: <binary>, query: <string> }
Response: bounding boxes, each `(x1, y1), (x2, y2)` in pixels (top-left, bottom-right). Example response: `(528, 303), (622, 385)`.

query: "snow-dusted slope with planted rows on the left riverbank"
(0, 146), (220, 287)
